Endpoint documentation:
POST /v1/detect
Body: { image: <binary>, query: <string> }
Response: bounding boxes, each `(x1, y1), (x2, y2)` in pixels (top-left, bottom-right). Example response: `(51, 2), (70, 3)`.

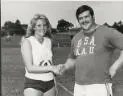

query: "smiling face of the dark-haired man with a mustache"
(78, 11), (94, 30)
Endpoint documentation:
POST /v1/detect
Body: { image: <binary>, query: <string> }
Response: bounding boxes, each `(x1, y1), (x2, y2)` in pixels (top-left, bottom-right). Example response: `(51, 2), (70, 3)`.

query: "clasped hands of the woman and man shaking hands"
(52, 64), (65, 75)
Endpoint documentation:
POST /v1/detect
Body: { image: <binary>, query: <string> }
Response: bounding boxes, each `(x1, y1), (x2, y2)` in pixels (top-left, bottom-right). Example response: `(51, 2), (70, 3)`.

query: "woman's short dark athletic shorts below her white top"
(24, 77), (55, 93)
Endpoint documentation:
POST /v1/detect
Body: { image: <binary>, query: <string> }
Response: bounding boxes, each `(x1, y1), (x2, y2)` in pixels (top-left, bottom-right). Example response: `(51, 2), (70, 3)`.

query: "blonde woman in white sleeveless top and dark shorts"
(21, 14), (60, 96)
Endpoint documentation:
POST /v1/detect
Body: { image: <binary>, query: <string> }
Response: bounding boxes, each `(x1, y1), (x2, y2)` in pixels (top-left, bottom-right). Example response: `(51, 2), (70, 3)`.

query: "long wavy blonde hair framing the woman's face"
(25, 14), (52, 38)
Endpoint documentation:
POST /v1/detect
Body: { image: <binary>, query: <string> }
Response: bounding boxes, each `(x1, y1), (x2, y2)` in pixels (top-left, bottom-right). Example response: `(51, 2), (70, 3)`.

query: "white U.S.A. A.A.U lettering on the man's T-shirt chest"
(75, 36), (96, 56)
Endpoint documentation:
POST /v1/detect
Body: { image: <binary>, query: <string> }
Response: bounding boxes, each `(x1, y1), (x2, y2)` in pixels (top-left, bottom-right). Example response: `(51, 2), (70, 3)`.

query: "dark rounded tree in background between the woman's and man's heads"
(57, 19), (74, 32)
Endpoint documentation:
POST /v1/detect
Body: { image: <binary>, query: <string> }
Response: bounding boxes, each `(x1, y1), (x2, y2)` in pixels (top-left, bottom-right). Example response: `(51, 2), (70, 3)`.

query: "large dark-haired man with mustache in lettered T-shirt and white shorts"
(61, 5), (123, 96)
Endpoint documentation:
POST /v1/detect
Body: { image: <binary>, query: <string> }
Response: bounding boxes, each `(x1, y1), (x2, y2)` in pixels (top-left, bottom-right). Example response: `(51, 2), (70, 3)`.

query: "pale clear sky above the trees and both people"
(1, 1), (123, 28)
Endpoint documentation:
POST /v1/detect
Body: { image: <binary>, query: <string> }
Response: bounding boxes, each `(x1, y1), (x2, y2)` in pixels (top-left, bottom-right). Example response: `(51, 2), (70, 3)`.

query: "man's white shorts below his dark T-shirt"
(74, 83), (112, 96)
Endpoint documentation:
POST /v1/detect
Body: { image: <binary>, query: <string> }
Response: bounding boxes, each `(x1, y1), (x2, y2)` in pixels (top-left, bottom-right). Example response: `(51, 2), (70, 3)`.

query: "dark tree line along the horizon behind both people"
(1, 19), (123, 36)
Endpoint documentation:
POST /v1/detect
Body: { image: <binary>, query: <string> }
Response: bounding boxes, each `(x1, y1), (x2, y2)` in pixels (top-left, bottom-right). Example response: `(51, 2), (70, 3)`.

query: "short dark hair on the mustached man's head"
(76, 5), (94, 20)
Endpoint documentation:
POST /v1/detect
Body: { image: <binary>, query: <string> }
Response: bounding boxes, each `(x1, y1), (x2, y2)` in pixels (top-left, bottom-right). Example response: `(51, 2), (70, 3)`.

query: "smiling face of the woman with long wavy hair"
(34, 19), (47, 37)
